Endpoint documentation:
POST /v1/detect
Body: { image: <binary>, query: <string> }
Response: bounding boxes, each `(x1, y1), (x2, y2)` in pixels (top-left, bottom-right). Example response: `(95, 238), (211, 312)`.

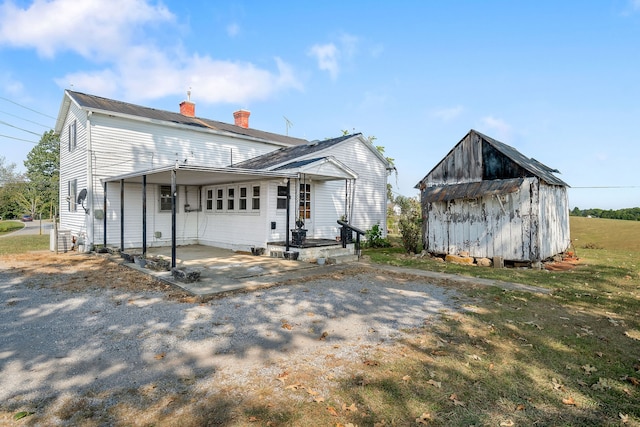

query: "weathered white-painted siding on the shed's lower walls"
(423, 178), (569, 261)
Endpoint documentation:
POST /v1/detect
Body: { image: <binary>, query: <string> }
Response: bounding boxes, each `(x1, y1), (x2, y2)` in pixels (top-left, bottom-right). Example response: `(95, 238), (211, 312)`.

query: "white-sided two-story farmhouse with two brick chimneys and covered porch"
(55, 90), (390, 264)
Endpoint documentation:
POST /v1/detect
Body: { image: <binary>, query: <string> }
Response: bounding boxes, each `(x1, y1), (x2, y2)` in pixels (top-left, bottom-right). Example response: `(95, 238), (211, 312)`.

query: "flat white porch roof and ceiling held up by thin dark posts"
(101, 165), (298, 185)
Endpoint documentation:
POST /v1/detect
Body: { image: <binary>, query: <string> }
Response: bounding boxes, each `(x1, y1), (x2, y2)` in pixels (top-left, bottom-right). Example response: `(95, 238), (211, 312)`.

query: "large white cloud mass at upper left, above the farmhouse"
(0, 0), (302, 105)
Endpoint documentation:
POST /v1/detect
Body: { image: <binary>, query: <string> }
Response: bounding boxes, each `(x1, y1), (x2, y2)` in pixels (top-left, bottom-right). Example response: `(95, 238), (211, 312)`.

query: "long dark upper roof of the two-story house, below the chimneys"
(56, 90), (307, 145)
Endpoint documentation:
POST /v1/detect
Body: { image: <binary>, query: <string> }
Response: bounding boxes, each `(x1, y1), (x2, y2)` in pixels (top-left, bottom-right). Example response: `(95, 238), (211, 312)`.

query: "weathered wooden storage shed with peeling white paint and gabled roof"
(416, 129), (570, 262)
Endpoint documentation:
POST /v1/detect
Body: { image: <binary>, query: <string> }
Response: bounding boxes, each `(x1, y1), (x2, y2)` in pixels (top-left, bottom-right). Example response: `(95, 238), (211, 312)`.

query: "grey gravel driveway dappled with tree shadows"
(0, 254), (458, 422)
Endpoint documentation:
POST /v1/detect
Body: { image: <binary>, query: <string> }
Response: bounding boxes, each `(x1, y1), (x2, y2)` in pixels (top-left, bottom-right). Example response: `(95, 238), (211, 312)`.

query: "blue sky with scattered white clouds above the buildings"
(0, 0), (640, 209)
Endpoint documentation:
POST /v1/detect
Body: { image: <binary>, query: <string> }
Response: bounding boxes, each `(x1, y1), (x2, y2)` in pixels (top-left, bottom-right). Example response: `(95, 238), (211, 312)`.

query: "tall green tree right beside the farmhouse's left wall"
(20, 130), (60, 217)
